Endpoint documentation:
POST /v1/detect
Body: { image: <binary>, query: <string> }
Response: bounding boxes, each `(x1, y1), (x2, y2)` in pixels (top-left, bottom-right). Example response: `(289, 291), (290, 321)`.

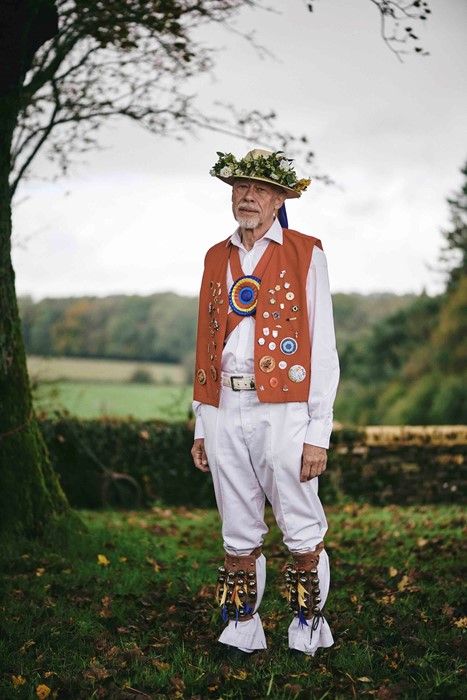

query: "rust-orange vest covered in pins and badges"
(194, 229), (322, 406)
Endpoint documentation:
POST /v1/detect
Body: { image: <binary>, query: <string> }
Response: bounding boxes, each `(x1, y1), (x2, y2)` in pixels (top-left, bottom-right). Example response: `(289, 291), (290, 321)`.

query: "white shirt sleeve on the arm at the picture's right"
(305, 245), (340, 449)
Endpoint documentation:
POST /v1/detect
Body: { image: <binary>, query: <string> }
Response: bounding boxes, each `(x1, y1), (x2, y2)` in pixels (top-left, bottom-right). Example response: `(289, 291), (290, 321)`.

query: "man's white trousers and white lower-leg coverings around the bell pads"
(200, 386), (334, 655)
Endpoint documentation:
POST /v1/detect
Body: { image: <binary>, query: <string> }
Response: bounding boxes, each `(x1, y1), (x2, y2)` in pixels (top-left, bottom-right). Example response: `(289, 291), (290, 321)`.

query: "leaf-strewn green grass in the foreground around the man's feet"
(0, 504), (467, 700)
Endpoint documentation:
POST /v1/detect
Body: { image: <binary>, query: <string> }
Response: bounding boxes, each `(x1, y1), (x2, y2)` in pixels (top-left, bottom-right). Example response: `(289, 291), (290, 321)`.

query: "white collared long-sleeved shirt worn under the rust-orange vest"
(193, 219), (340, 448)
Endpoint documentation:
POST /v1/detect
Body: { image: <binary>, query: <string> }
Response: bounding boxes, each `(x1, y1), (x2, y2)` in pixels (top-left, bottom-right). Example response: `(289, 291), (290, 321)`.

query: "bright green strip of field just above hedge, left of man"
(34, 381), (192, 420)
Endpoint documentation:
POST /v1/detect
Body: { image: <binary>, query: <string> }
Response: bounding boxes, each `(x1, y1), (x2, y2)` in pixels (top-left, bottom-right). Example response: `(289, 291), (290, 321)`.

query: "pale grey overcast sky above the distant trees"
(13, 0), (467, 299)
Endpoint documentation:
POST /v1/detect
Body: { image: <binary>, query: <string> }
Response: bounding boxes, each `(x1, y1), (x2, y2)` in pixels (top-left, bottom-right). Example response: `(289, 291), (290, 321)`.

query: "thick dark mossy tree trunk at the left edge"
(0, 0), (79, 539)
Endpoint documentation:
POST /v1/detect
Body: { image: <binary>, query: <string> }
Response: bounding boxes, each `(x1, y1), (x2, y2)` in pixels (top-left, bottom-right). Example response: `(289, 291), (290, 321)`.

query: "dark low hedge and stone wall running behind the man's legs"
(39, 415), (467, 508)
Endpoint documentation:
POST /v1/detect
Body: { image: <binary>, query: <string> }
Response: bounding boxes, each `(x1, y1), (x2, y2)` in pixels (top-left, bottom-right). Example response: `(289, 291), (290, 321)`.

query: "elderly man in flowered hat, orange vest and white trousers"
(192, 149), (339, 655)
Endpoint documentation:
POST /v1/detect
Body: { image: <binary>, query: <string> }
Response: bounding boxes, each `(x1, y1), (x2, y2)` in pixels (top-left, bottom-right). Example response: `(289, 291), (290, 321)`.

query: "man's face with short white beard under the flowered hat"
(232, 179), (285, 229)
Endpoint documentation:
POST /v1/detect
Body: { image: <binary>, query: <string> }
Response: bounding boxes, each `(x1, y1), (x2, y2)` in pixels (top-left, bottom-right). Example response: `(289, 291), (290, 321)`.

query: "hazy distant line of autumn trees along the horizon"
(19, 292), (416, 363)
